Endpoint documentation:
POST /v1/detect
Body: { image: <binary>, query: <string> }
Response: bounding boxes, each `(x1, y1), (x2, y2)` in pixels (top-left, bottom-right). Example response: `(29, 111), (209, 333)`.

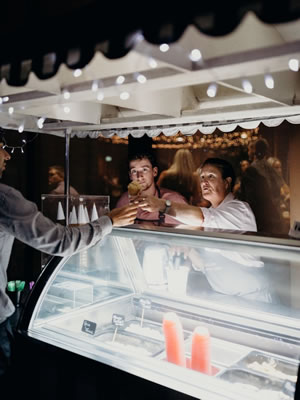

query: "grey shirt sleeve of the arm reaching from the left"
(0, 188), (112, 257)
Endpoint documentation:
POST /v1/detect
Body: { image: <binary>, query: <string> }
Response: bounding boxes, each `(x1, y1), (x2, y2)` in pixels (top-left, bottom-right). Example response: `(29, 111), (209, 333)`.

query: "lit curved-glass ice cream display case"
(17, 227), (300, 400)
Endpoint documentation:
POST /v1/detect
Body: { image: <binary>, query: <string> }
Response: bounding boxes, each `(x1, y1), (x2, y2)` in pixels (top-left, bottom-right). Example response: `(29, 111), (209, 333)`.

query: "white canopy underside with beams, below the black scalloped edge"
(0, 12), (300, 138)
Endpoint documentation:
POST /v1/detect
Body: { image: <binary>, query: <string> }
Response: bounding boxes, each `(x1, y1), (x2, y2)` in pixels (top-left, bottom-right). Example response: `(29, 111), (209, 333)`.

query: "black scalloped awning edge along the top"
(0, 0), (300, 86)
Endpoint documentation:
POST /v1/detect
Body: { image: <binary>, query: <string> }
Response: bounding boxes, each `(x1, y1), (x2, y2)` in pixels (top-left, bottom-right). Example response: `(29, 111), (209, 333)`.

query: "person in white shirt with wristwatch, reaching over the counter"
(137, 158), (257, 231)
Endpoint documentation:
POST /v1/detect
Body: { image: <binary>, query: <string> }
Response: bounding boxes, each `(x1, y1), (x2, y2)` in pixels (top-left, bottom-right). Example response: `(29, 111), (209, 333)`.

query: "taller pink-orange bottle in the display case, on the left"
(163, 312), (186, 367)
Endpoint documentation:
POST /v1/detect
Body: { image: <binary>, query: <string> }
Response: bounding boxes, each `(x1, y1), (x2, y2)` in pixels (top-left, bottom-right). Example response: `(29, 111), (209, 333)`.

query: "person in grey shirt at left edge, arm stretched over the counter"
(0, 132), (137, 386)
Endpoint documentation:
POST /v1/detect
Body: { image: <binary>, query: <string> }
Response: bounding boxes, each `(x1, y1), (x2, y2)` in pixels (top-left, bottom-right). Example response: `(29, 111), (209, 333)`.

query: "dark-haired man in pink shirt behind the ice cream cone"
(117, 152), (187, 225)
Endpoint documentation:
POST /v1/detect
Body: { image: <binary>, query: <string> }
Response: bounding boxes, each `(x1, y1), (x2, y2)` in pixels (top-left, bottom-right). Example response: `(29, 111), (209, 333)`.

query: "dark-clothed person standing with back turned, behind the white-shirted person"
(239, 139), (285, 234)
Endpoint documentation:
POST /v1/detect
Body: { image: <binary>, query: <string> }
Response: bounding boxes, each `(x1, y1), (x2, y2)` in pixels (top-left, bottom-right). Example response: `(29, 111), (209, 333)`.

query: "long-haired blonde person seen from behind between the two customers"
(157, 149), (209, 207)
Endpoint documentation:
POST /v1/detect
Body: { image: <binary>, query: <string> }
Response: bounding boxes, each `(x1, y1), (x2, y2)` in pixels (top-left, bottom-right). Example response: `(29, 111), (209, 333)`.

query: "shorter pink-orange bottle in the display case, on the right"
(191, 326), (212, 375)
